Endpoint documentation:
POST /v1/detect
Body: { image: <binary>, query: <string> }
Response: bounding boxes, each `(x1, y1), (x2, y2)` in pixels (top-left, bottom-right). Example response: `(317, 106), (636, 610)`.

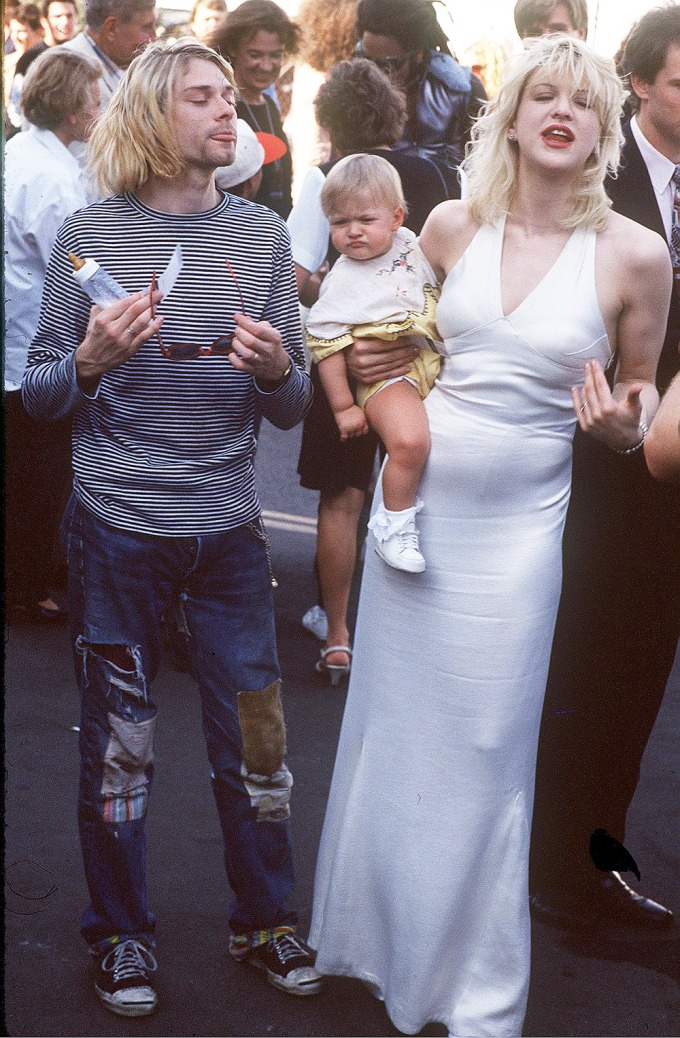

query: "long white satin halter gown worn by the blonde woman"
(309, 222), (610, 1038)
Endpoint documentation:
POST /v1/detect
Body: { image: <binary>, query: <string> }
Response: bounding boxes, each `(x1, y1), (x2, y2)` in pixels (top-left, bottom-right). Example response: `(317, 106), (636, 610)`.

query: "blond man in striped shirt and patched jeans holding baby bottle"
(23, 39), (320, 1016)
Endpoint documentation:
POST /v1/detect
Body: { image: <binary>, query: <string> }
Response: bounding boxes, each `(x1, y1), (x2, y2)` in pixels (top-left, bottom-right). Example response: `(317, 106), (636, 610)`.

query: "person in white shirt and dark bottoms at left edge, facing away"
(3, 47), (102, 622)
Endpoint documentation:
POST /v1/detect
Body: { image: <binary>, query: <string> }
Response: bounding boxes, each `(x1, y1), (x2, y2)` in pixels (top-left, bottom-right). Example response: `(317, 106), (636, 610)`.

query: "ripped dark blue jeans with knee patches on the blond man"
(62, 497), (297, 949)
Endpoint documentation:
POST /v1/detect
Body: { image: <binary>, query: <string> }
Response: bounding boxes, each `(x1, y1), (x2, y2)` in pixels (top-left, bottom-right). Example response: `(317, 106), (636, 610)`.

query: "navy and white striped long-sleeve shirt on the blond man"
(23, 194), (311, 537)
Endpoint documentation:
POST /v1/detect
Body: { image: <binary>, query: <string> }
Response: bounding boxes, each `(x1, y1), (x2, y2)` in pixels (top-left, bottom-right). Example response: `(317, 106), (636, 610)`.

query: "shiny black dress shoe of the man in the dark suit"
(529, 872), (674, 931)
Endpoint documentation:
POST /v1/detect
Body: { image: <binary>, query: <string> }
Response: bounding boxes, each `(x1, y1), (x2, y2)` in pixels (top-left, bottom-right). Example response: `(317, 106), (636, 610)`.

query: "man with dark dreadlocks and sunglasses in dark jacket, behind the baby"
(355, 0), (486, 198)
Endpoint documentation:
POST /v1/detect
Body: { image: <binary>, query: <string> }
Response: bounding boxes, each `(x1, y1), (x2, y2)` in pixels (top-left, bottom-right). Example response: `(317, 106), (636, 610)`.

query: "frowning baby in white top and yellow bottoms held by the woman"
(306, 155), (440, 573)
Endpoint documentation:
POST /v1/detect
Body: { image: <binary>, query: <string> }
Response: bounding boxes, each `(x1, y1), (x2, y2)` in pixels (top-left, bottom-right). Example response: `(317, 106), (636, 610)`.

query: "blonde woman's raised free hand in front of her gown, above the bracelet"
(571, 360), (648, 452)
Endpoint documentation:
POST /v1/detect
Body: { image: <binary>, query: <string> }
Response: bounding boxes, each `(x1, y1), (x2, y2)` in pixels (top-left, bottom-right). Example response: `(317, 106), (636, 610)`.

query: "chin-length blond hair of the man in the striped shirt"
(87, 36), (235, 194)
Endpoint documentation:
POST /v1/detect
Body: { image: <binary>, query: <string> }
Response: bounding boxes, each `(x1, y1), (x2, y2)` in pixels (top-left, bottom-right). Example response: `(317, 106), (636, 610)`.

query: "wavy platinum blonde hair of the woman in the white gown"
(462, 35), (624, 230)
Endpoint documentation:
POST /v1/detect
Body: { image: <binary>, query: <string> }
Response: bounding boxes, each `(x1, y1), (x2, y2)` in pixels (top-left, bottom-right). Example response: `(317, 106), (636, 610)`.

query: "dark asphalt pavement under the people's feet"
(4, 425), (680, 1038)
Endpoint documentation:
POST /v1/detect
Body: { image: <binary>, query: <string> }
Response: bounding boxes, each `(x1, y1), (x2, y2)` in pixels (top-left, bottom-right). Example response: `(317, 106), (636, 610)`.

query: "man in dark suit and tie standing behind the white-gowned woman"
(532, 4), (680, 927)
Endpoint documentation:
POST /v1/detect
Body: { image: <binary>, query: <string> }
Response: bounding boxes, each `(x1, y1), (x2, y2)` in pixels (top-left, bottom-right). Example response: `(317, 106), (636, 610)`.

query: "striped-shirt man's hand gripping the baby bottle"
(76, 291), (163, 392)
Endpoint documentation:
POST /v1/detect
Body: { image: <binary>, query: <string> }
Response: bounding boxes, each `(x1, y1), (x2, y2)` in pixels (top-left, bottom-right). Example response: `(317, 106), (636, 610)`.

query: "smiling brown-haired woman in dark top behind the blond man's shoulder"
(208, 0), (300, 219)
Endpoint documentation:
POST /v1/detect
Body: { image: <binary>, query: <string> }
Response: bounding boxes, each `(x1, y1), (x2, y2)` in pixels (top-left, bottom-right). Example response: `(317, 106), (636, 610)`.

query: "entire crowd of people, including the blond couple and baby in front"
(3, 0), (680, 1038)
